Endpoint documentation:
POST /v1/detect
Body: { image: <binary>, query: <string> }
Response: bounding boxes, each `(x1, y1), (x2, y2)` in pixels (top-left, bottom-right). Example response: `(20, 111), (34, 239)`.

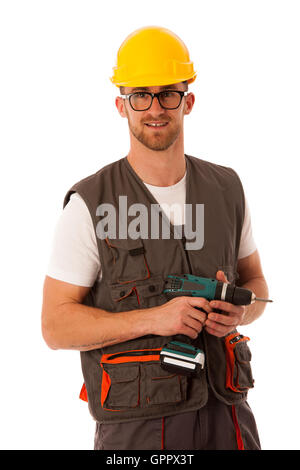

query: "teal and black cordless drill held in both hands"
(160, 274), (272, 376)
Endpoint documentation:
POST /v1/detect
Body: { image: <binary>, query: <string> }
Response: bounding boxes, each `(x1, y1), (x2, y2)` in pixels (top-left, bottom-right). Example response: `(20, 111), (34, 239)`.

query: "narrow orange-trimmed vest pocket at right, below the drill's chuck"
(225, 332), (254, 393)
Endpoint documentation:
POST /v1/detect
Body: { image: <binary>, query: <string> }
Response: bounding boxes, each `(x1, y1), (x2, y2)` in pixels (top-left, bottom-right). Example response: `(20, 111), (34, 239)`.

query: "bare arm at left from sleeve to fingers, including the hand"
(42, 276), (212, 351)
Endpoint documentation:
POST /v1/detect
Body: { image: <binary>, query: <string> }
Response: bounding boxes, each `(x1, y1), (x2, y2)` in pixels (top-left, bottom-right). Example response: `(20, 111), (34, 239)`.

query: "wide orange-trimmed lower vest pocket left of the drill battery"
(101, 348), (187, 412)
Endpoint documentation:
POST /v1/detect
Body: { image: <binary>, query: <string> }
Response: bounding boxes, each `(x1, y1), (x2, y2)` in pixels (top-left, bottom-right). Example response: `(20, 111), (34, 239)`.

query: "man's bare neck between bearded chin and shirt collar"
(127, 131), (186, 186)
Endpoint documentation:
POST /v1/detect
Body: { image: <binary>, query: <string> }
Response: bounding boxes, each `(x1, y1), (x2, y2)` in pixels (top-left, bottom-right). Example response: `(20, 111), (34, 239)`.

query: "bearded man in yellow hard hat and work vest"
(42, 27), (268, 450)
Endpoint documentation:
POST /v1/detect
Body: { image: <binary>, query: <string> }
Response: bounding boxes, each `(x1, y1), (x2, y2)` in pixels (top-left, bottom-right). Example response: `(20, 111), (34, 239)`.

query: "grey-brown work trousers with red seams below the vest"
(94, 393), (260, 450)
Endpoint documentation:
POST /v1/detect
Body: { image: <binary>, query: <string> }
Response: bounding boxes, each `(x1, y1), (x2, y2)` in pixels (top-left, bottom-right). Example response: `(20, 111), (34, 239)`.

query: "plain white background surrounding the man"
(0, 0), (300, 449)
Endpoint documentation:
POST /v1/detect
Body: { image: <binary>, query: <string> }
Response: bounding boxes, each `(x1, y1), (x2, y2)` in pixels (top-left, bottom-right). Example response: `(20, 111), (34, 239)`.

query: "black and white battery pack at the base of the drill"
(160, 341), (205, 376)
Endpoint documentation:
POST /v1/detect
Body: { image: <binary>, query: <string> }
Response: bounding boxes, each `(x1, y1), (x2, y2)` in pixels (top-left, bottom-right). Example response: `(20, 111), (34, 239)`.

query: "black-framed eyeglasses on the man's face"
(121, 90), (188, 111)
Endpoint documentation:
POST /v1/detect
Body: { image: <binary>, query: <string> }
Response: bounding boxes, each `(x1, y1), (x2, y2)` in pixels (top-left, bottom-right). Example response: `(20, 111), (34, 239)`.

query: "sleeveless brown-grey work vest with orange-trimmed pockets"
(64, 155), (253, 423)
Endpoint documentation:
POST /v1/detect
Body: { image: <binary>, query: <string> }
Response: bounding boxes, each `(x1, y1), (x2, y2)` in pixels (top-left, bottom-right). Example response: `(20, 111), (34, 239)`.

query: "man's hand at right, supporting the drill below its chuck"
(205, 271), (246, 337)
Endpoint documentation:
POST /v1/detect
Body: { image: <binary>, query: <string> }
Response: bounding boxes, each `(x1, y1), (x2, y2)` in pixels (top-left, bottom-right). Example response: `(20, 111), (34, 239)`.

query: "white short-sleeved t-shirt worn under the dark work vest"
(47, 175), (256, 287)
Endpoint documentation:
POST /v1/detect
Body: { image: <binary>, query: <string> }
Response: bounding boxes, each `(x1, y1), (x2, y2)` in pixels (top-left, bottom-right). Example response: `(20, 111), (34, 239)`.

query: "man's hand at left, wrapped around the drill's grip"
(151, 297), (213, 339)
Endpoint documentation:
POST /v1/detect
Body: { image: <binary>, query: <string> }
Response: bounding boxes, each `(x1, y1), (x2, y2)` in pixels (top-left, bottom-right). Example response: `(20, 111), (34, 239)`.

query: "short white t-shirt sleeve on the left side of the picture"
(47, 193), (101, 287)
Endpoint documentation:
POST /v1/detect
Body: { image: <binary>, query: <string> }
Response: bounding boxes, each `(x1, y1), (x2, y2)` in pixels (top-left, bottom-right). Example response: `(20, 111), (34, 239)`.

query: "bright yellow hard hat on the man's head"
(111, 26), (196, 87)
